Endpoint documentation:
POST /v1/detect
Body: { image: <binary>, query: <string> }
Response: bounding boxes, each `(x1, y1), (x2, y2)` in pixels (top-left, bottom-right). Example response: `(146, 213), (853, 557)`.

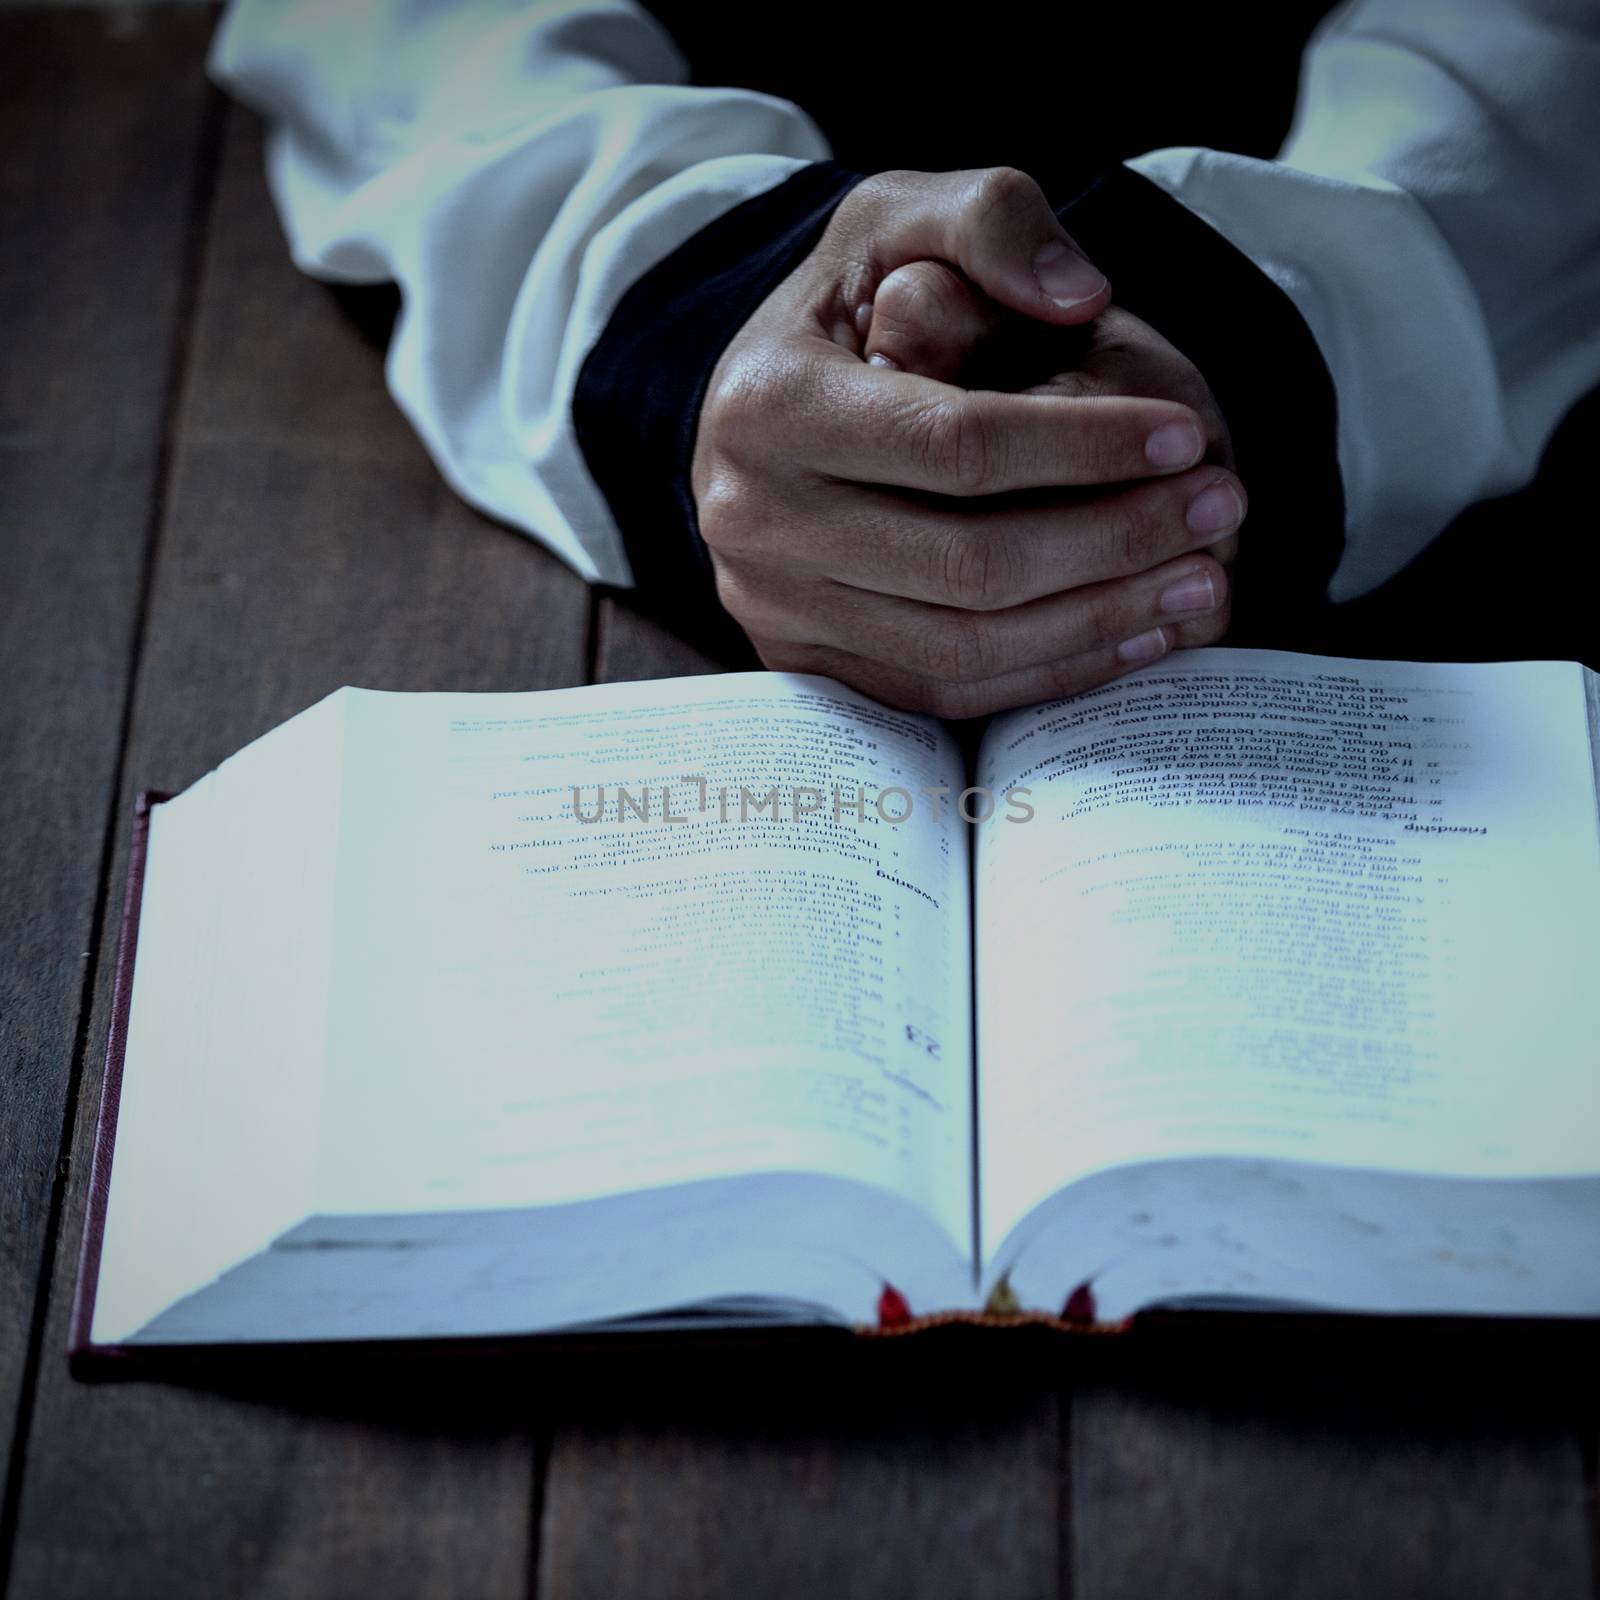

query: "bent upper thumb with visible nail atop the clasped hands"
(883, 166), (1110, 326)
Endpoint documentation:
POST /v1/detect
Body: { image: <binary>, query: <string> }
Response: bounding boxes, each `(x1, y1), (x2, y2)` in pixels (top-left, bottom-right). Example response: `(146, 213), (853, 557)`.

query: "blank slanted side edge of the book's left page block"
(94, 694), (344, 1341)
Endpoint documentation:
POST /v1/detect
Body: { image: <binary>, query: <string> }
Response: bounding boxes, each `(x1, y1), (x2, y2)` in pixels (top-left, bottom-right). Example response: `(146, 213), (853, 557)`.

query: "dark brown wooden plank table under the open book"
(0, 8), (1597, 1600)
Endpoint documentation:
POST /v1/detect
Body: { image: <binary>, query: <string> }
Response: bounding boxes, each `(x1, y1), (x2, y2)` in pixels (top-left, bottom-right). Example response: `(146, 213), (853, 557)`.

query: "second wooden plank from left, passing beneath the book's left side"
(14, 114), (589, 1600)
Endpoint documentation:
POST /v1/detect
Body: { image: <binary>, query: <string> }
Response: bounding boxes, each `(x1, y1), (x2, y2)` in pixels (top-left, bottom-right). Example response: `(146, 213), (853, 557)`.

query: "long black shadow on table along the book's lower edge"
(68, 1312), (1600, 1437)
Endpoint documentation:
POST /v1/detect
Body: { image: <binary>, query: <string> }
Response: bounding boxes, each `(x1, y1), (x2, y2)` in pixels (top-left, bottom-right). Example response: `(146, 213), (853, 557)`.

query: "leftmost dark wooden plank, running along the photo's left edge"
(0, 8), (219, 1548)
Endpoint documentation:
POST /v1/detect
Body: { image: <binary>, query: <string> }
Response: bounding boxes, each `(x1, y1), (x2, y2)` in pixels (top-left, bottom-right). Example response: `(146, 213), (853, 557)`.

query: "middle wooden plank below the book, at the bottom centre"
(538, 1376), (1062, 1600)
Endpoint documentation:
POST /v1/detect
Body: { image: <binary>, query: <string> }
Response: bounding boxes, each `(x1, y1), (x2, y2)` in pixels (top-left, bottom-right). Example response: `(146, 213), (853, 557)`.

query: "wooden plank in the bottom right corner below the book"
(1069, 1326), (1594, 1600)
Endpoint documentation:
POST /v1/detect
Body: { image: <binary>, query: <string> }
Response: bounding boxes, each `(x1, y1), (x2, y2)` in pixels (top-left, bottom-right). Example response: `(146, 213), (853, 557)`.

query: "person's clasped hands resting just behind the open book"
(691, 168), (1245, 717)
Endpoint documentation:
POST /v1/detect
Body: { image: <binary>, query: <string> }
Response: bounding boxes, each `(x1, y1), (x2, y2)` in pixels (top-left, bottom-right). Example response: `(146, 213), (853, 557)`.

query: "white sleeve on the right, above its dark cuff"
(1130, 0), (1600, 600)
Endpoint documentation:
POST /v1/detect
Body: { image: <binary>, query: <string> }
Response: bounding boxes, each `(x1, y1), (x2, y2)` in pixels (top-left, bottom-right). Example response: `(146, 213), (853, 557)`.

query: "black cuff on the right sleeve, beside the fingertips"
(1058, 166), (1344, 636)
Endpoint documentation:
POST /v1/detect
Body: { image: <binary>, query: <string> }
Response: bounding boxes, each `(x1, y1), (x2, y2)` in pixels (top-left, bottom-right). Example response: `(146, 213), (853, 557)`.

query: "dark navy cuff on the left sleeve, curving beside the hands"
(573, 162), (862, 656)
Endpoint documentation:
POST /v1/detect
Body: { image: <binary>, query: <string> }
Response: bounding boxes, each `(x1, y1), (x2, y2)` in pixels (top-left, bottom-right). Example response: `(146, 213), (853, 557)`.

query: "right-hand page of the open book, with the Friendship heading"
(976, 650), (1600, 1254)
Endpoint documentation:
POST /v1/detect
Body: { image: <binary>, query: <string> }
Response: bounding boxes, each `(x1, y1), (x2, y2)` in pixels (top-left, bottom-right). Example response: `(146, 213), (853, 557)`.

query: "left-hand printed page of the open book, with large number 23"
(305, 674), (971, 1259)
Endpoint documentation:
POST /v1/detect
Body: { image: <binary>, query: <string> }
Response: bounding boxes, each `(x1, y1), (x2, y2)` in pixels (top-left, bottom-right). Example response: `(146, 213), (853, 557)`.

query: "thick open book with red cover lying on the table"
(78, 650), (1600, 1347)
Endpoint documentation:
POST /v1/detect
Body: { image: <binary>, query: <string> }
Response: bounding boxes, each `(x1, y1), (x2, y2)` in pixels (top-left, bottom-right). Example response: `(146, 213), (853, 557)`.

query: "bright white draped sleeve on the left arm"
(211, 0), (829, 584)
